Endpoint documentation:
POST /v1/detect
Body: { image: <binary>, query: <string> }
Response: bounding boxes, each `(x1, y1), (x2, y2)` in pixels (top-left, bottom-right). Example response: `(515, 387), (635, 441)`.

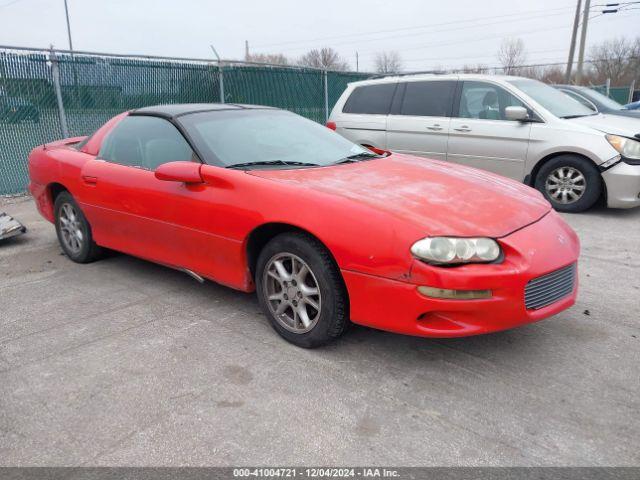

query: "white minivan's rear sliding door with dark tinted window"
(387, 80), (457, 160)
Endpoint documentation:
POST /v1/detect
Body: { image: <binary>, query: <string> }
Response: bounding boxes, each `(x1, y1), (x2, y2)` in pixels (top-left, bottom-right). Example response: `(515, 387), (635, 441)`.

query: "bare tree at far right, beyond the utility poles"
(589, 37), (640, 85)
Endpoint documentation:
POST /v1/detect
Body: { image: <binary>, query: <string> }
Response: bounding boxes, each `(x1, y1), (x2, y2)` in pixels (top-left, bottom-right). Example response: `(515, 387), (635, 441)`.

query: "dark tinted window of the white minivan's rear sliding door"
(400, 80), (456, 117)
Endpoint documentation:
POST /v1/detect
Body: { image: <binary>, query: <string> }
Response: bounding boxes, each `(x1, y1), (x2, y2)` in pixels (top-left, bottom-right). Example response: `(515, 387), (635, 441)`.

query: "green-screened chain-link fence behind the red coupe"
(0, 48), (369, 195)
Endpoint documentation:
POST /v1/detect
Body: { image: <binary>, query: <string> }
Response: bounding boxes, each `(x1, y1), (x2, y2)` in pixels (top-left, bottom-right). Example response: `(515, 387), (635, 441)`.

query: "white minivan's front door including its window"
(447, 80), (533, 181)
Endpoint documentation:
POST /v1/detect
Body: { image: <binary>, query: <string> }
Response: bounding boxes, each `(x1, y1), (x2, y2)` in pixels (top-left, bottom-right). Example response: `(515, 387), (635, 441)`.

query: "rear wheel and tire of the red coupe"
(53, 192), (102, 263)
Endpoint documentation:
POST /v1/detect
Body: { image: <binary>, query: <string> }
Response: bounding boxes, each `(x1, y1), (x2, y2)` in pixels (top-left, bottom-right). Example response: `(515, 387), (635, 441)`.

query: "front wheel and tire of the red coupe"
(255, 232), (349, 348)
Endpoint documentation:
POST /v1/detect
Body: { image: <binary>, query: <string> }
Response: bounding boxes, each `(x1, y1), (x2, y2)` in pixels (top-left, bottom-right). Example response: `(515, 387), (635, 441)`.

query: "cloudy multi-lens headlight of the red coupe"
(411, 237), (500, 265)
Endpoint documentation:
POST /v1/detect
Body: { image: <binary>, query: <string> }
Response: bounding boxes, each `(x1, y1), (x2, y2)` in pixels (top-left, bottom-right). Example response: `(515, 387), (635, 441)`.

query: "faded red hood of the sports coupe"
(248, 154), (551, 238)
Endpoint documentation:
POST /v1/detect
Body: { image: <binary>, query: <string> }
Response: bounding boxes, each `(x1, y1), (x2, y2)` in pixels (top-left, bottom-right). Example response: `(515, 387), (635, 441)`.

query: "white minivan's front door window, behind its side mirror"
(458, 82), (527, 120)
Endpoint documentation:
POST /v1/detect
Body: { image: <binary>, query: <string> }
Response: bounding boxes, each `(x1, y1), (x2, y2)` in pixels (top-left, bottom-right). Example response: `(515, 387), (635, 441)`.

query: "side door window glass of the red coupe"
(99, 115), (195, 170)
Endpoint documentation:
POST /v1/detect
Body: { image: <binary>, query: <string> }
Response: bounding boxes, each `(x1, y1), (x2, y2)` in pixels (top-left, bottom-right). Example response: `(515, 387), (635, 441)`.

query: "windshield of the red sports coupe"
(180, 109), (371, 168)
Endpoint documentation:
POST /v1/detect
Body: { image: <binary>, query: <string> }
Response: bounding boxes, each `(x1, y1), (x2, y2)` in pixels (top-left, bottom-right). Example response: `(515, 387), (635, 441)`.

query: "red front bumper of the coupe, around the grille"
(343, 211), (580, 337)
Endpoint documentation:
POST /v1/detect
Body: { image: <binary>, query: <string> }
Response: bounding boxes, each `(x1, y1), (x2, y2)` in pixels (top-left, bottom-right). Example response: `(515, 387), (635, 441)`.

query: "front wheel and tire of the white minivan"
(535, 155), (602, 213)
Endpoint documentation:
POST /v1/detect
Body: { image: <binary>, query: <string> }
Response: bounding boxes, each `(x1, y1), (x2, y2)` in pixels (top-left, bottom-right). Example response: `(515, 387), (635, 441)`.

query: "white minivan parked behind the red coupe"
(327, 74), (640, 212)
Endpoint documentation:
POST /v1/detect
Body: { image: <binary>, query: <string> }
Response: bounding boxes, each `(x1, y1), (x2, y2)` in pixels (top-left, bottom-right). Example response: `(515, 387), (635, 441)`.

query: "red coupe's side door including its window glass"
(80, 115), (216, 275)
